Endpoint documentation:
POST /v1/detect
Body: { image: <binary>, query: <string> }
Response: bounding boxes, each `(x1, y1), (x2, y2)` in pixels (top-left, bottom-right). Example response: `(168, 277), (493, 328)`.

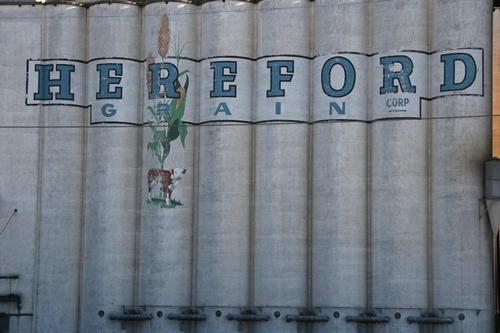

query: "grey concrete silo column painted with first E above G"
(80, 4), (142, 332)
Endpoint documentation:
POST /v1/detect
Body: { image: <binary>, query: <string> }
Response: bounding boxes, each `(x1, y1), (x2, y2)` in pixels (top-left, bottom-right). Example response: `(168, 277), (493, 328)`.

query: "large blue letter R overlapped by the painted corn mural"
(149, 62), (181, 99)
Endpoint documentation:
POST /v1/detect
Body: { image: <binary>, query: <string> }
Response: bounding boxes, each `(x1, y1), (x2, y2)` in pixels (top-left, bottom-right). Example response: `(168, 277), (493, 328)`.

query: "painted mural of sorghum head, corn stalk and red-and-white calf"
(146, 15), (189, 208)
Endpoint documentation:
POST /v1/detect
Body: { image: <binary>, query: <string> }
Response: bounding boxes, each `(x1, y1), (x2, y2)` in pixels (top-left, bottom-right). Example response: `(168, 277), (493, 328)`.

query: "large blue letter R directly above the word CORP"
(380, 55), (417, 94)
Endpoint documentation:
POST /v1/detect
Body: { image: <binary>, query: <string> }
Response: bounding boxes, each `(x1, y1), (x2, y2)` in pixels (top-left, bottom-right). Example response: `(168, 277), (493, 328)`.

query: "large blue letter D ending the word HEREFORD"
(439, 53), (477, 92)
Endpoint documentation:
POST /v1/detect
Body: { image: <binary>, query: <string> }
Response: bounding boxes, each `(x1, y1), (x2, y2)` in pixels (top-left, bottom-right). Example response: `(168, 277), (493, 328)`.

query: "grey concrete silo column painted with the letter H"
(34, 6), (87, 332)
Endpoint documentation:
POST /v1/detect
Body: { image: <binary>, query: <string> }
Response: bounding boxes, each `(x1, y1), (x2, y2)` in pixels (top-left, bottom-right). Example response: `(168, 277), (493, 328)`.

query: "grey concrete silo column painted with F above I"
(254, 0), (311, 333)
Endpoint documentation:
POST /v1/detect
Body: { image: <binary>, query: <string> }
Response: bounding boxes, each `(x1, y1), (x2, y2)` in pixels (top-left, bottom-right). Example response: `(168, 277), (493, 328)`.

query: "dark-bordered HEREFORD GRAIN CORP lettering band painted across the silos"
(26, 48), (484, 123)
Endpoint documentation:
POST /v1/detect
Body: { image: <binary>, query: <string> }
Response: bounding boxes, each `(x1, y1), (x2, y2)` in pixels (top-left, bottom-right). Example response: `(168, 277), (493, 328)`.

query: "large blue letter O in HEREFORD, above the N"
(321, 57), (356, 97)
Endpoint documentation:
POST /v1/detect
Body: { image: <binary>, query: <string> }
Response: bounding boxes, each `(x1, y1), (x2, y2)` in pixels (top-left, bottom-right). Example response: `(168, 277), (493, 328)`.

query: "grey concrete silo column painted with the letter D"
(429, 1), (494, 332)
